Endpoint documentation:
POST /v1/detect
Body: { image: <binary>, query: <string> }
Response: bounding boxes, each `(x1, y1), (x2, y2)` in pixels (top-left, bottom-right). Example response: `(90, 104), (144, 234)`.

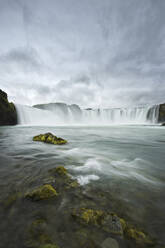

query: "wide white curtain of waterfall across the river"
(16, 105), (159, 125)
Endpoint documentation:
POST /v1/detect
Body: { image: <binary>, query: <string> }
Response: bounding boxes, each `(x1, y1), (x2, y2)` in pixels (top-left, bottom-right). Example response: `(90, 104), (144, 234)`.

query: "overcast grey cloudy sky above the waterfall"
(0, 0), (165, 108)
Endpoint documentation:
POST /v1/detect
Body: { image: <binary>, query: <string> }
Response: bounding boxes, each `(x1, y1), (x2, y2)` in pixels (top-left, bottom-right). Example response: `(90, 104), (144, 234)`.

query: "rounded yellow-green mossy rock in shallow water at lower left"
(25, 184), (58, 201)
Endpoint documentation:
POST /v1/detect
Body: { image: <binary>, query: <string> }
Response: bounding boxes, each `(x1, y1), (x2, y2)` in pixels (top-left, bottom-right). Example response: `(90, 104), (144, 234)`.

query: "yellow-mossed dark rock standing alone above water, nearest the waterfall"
(33, 133), (67, 145)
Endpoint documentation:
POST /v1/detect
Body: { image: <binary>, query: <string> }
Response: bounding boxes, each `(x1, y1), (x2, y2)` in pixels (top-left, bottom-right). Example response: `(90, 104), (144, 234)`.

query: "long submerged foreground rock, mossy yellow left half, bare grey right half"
(72, 208), (123, 235)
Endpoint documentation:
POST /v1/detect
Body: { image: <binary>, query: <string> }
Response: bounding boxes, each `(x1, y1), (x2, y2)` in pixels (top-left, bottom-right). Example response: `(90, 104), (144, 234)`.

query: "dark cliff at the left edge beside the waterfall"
(0, 90), (17, 126)
